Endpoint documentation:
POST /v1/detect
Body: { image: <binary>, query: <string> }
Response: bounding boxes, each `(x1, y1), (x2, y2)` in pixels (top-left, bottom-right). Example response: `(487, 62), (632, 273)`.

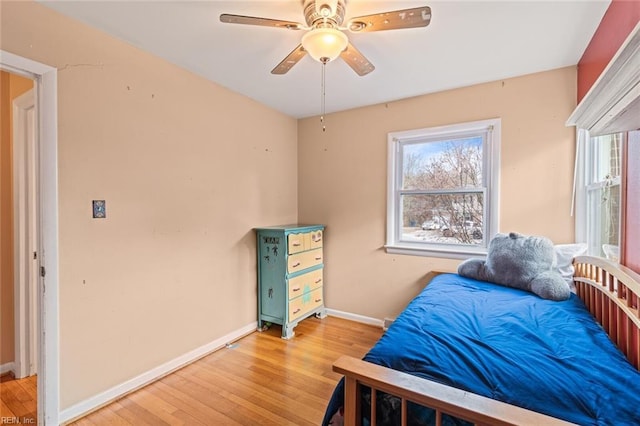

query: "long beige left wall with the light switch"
(0, 2), (297, 409)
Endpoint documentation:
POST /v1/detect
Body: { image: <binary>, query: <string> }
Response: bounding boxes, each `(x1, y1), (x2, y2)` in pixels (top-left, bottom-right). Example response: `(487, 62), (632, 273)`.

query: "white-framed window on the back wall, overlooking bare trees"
(386, 119), (500, 258)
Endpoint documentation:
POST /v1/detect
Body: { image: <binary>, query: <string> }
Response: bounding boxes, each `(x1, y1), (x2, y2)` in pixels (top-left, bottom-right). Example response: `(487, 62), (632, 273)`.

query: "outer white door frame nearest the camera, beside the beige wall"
(0, 50), (60, 425)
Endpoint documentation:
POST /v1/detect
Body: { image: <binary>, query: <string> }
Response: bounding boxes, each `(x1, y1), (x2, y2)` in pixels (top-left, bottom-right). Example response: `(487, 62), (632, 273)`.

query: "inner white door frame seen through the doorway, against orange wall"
(12, 88), (40, 379)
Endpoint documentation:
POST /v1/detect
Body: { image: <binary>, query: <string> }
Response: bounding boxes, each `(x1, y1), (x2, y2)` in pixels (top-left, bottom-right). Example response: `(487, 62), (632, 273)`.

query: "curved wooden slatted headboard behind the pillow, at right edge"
(573, 256), (640, 369)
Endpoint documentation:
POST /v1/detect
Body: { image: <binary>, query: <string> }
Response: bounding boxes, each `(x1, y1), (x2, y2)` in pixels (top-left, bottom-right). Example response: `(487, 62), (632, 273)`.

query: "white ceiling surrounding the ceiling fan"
(42, 0), (609, 118)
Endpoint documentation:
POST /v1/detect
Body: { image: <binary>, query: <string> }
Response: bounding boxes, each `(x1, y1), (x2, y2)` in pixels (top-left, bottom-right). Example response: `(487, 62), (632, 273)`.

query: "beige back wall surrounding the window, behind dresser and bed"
(298, 67), (576, 318)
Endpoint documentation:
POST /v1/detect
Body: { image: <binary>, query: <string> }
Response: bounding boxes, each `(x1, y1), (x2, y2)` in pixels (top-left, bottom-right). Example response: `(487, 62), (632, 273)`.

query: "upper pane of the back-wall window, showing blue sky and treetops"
(402, 136), (483, 189)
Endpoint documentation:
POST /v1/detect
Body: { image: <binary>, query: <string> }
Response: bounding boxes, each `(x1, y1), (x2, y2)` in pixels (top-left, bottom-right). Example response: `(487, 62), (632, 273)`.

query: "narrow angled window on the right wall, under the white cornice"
(581, 133), (624, 262)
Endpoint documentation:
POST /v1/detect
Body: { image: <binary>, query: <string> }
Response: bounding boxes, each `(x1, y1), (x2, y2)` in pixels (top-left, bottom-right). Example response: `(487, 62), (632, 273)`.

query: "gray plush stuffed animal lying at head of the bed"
(458, 232), (571, 301)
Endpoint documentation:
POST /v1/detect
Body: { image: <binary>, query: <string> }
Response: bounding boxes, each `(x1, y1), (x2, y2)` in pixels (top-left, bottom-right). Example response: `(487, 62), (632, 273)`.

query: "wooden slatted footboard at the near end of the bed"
(333, 356), (572, 426)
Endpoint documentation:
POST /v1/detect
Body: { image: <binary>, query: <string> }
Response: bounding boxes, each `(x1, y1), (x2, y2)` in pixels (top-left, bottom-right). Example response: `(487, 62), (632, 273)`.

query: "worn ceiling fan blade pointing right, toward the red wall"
(347, 6), (431, 33)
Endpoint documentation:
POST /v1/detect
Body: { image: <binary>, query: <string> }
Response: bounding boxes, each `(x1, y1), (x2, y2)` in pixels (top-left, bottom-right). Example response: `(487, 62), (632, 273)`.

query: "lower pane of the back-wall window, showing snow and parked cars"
(401, 192), (484, 245)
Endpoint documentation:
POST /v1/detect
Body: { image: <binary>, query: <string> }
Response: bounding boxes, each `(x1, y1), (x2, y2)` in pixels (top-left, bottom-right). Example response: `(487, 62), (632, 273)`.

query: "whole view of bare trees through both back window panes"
(402, 136), (484, 244)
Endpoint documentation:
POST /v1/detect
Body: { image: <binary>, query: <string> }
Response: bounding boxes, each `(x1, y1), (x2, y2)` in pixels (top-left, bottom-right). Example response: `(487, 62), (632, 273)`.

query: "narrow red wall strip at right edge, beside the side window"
(622, 130), (640, 273)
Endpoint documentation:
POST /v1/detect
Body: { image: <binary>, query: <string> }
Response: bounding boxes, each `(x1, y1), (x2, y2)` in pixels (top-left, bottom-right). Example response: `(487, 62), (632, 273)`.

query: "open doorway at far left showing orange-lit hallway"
(0, 67), (40, 423)
